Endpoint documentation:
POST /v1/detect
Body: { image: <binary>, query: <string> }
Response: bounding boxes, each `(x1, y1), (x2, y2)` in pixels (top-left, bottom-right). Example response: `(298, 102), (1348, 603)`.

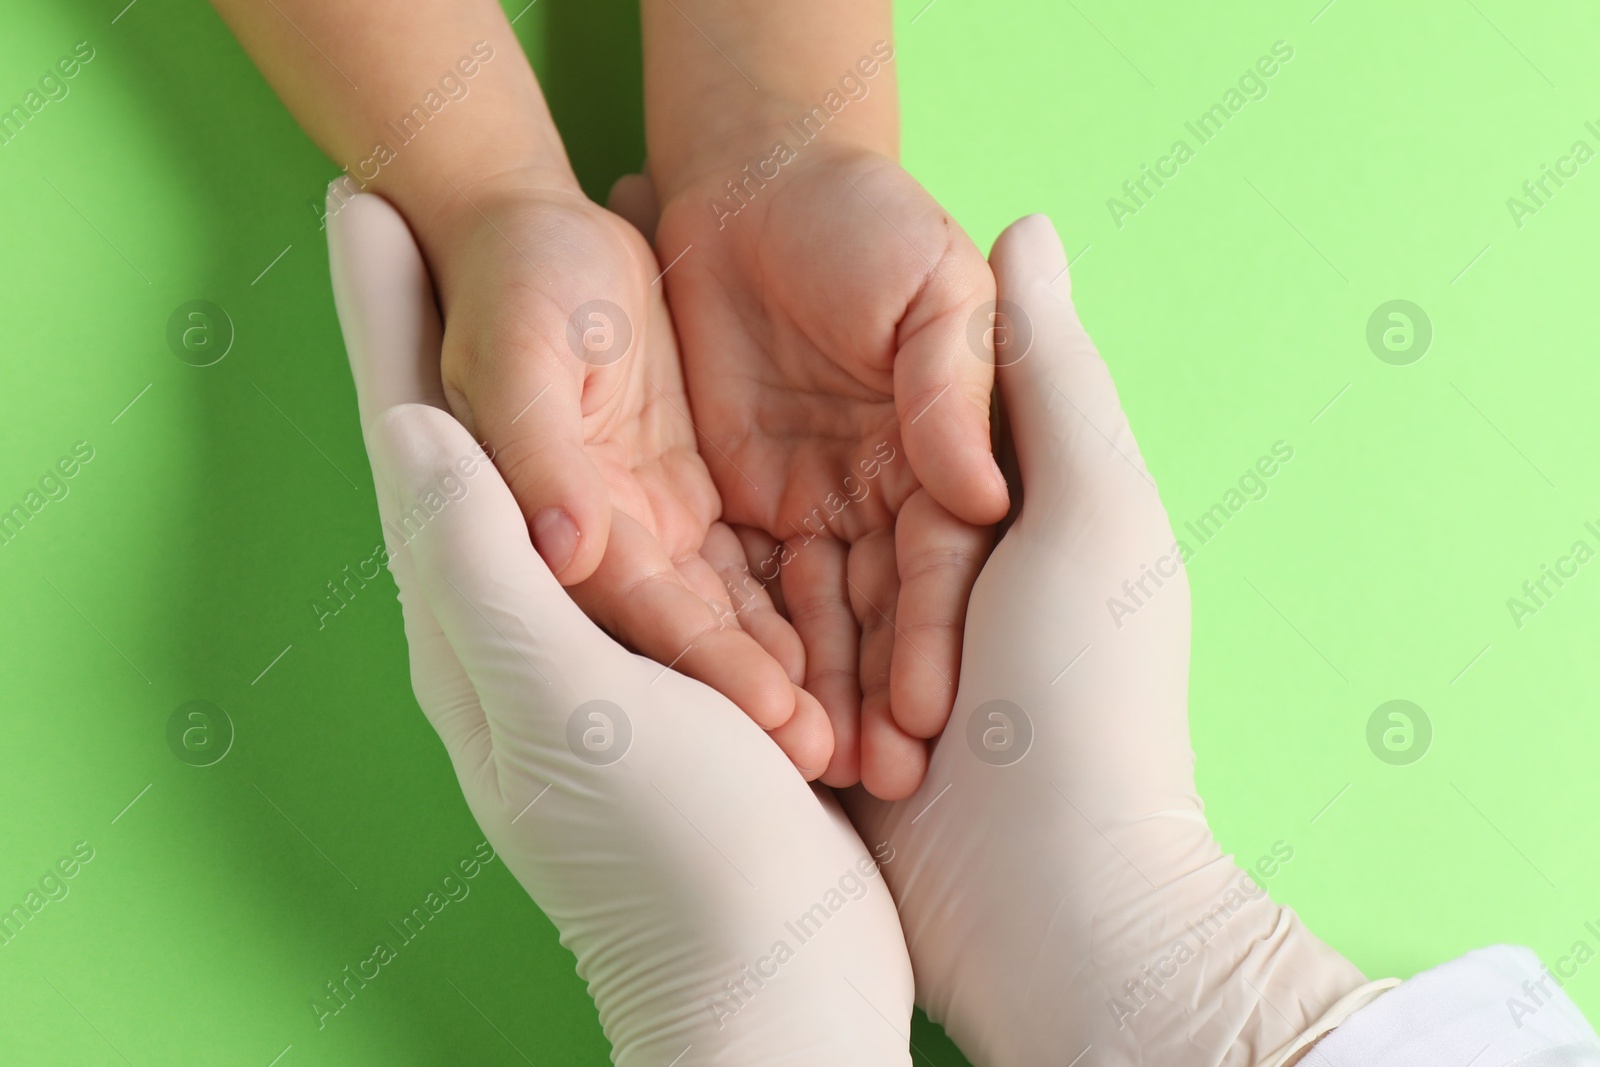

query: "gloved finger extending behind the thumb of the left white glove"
(328, 186), (490, 774)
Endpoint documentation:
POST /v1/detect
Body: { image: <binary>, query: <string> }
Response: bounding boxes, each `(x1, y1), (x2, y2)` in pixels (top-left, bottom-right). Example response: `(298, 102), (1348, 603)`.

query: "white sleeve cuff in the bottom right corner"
(1301, 945), (1600, 1067)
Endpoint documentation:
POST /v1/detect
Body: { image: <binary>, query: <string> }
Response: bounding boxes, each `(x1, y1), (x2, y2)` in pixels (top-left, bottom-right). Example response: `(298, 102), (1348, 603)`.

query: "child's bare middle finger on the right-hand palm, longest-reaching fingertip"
(846, 531), (928, 800)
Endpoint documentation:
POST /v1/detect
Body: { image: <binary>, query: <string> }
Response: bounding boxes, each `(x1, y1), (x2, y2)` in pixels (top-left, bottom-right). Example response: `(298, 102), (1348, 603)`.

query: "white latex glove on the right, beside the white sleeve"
(846, 216), (1365, 1067)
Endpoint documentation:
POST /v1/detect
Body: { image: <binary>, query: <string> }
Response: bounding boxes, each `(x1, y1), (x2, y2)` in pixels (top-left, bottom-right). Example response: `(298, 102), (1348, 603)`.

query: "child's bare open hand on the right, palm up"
(654, 146), (1006, 798)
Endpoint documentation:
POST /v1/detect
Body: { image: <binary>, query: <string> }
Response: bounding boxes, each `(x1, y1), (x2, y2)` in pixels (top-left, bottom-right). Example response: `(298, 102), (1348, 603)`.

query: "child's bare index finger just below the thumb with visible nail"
(573, 512), (795, 729)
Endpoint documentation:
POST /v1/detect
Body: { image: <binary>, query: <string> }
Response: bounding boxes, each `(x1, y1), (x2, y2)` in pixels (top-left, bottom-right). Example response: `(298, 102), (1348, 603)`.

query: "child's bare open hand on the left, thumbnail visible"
(412, 176), (832, 777)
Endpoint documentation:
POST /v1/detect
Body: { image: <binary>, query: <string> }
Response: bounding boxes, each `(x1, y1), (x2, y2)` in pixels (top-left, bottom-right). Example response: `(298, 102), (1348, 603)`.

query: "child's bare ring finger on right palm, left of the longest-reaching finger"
(777, 537), (861, 787)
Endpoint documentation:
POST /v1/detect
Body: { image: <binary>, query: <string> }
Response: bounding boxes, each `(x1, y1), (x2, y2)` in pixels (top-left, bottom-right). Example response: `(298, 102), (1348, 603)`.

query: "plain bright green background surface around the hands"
(0, 0), (1600, 1067)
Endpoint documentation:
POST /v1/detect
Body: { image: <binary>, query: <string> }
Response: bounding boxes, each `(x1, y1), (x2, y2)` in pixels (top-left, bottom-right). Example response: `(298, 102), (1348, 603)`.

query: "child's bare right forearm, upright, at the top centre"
(640, 0), (899, 200)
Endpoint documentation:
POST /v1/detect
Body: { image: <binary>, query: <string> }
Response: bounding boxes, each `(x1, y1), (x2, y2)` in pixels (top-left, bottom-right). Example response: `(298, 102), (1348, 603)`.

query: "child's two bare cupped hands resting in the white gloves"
(419, 144), (1008, 798)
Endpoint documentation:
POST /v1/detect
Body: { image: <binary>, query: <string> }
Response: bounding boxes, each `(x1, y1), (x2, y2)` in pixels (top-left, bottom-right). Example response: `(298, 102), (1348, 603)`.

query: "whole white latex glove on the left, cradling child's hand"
(328, 187), (912, 1067)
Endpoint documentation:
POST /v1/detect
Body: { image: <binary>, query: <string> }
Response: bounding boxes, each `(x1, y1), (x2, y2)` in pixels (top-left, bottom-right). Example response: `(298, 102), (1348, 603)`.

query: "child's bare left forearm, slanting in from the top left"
(213, 0), (576, 251)
